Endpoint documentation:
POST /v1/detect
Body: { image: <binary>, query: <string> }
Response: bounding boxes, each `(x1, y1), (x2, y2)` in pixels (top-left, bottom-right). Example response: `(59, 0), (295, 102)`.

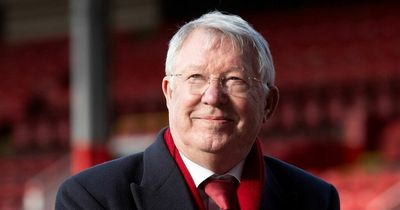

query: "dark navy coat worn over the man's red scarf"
(55, 130), (339, 210)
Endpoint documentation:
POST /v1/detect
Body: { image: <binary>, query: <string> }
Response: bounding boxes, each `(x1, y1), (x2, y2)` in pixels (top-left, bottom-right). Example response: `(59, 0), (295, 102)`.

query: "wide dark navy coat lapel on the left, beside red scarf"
(131, 130), (196, 210)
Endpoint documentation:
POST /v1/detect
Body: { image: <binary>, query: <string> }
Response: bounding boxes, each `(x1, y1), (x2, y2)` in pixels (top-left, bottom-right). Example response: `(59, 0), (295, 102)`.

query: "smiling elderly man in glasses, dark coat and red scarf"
(56, 12), (340, 210)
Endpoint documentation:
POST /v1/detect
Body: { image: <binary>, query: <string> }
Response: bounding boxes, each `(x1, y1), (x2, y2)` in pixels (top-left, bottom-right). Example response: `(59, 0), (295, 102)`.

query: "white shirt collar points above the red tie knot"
(179, 152), (244, 187)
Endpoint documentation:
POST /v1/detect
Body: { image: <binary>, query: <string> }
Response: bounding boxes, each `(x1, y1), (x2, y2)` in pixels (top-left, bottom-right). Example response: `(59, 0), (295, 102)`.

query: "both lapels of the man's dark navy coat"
(131, 129), (298, 210)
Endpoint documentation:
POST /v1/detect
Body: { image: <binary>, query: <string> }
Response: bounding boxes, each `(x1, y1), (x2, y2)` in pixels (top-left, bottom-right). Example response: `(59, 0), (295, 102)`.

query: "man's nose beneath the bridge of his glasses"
(201, 79), (227, 105)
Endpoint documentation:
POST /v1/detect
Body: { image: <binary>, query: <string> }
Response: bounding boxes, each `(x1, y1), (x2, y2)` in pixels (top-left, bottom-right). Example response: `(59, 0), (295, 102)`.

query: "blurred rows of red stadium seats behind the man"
(0, 1), (400, 210)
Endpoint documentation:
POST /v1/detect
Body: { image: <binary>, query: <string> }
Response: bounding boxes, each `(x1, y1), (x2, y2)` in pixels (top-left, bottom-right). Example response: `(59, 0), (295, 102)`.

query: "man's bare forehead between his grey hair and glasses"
(175, 28), (254, 75)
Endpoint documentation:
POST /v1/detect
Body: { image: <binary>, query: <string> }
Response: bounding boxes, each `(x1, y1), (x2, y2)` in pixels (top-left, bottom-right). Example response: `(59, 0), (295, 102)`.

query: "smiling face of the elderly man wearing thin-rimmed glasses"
(163, 29), (276, 161)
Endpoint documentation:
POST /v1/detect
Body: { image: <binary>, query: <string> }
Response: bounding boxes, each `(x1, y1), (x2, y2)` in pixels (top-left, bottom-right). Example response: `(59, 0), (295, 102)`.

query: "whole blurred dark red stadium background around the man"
(0, 0), (400, 210)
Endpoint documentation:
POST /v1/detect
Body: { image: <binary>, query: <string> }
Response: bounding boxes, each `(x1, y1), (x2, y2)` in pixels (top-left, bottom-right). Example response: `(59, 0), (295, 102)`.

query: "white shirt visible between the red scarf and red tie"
(179, 152), (244, 210)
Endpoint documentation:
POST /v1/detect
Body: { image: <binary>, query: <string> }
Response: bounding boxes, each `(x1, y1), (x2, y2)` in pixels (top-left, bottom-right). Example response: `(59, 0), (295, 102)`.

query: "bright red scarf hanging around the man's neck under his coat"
(164, 129), (264, 210)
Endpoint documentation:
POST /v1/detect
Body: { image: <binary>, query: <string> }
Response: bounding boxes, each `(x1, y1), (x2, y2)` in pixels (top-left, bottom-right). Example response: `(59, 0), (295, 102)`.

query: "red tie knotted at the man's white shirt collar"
(204, 176), (239, 210)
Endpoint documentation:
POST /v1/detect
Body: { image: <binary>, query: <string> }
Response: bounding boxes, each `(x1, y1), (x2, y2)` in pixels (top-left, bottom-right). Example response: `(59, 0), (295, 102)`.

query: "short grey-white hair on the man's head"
(165, 11), (275, 90)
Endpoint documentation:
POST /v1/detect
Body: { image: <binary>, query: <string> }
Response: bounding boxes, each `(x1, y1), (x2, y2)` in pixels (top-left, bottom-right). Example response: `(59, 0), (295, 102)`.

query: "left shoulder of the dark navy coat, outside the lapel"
(56, 153), (143, 209)
